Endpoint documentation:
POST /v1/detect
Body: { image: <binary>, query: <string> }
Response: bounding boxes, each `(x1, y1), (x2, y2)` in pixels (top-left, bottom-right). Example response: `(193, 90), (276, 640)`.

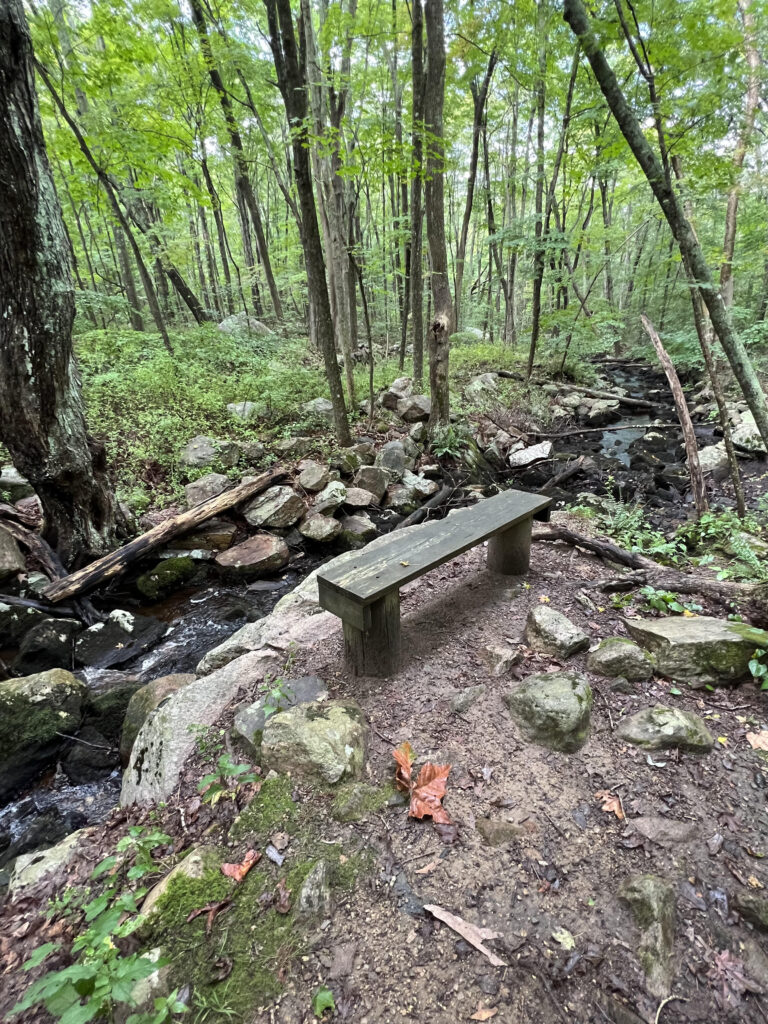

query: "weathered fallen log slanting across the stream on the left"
(42, 467), (286, 603)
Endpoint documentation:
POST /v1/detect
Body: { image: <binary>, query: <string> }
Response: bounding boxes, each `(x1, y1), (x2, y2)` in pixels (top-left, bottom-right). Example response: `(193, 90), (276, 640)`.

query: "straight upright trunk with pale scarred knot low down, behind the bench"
(424, 0), (454, 425)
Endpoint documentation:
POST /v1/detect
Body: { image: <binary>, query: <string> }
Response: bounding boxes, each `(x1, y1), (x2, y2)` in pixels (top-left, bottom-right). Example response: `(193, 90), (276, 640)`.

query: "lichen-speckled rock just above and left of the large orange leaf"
(261, 700), (368, 784)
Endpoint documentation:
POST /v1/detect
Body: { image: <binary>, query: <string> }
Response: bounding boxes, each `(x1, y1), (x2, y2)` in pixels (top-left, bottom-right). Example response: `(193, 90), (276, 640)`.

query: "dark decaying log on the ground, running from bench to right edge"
(532, 523), (768, 627)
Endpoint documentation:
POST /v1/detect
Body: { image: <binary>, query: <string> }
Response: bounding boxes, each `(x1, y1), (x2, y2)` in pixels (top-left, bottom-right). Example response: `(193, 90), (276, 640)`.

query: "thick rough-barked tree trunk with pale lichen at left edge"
(0, 0), (115, 565)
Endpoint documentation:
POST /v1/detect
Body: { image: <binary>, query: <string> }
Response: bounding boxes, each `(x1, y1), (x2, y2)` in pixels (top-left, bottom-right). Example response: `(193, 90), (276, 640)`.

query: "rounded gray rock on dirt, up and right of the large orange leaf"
(504, 672), (592, 754)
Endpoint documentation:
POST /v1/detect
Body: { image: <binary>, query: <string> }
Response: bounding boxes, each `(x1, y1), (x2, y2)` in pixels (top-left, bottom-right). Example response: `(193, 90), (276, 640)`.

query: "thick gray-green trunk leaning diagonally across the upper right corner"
(564, 0), (768, 447)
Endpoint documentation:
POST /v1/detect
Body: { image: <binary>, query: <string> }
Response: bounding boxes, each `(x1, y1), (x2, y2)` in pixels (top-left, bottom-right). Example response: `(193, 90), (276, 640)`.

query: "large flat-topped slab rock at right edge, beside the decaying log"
(626, 615), (768, 689)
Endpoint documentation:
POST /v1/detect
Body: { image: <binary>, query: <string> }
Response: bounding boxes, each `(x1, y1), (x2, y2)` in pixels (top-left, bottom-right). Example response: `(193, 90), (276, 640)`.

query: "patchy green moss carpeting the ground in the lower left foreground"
(142, 776), (372, 1024)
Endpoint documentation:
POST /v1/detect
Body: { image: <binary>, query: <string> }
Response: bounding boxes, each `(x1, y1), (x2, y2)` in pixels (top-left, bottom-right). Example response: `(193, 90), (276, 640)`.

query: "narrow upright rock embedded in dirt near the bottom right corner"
(620, 874), (675, 999)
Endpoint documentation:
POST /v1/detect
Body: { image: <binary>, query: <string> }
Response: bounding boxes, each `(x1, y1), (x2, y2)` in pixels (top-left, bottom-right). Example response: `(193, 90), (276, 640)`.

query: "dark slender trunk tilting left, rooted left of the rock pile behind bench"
(264, 0), (351, 446)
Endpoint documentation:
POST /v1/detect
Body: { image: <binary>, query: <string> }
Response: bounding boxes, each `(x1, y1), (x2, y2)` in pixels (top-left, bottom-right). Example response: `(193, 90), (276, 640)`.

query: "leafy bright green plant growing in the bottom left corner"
(8, 826), (181, 1024)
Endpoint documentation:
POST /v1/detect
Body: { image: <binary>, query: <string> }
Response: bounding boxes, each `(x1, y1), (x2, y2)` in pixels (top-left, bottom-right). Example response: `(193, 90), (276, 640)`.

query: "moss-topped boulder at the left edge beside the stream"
(0, 669), (87, 805)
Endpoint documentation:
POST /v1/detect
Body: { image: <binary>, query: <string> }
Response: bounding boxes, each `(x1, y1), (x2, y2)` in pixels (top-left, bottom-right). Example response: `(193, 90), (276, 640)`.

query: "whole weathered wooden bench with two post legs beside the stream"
(317, 490), (552, 676)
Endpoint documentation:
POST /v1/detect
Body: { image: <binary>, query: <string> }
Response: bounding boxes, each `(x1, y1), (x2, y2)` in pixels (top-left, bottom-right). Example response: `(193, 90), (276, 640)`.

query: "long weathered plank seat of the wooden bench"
(317, 490), (552, 606)
